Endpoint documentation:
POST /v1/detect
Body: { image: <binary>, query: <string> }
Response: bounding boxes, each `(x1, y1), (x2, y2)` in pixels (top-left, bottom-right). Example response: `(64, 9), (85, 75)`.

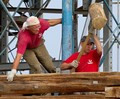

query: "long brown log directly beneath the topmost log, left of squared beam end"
(0, 79), (105, 94)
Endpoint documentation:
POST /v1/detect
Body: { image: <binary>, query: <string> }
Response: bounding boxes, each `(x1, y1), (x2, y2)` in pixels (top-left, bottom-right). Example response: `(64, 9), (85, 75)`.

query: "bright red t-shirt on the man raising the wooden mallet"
(64, 50), (101, 72)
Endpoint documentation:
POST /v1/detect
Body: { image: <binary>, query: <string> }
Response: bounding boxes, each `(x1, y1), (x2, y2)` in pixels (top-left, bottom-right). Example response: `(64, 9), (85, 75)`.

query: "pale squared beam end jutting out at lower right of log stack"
(105, 86), (120, 98)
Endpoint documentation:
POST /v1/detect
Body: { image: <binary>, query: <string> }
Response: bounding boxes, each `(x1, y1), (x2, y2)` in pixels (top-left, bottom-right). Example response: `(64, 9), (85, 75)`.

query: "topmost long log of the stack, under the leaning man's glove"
(0, 72), (120, 85)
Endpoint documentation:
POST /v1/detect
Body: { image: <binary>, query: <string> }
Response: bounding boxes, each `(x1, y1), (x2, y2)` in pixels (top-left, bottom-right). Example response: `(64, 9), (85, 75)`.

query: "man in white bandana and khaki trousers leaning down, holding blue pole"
(7, 16), (61, 81)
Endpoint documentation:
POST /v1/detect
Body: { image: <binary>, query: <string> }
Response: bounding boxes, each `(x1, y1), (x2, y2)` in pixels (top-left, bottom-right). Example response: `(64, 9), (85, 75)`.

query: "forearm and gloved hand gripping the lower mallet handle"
(60, 60), (78, 70)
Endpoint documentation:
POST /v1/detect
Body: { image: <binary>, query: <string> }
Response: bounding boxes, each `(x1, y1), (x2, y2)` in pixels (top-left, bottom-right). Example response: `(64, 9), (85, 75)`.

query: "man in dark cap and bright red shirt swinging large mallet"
(61, 34), (102, 72)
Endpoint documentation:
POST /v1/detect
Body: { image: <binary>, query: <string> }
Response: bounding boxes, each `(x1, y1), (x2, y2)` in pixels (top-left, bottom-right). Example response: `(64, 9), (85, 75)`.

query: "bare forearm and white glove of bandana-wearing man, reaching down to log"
(7, 53), (22, 81)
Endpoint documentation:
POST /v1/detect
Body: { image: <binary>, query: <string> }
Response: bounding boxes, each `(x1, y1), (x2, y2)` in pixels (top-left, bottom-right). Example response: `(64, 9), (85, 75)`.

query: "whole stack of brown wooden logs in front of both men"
(0, 72), (120, 99)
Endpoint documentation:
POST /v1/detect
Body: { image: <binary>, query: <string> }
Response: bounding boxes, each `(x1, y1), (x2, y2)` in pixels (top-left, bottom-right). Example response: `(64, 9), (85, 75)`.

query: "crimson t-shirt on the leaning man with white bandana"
(17, 19), (50, 54)
